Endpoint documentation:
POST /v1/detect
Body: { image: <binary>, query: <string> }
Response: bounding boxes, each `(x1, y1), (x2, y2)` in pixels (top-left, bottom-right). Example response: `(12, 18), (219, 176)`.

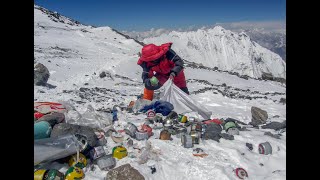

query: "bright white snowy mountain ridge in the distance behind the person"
(144, 26), (286, 78)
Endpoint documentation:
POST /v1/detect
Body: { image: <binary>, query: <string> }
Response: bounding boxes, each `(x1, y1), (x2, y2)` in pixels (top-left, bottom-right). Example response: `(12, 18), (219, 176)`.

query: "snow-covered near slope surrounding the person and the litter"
(34, 6), (286, 180)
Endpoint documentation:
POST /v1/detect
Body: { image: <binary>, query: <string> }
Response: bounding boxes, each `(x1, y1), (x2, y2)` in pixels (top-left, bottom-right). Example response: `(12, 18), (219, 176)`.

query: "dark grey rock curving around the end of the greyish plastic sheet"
(50, 123), (98, 147)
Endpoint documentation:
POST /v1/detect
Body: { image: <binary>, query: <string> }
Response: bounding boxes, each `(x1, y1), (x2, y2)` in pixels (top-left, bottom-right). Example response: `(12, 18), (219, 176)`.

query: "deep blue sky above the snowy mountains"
(34, 0), (286, 31)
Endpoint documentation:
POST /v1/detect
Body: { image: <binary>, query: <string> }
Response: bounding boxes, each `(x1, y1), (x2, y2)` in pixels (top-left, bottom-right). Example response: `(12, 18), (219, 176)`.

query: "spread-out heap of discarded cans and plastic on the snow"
(34, 87), (285, 179)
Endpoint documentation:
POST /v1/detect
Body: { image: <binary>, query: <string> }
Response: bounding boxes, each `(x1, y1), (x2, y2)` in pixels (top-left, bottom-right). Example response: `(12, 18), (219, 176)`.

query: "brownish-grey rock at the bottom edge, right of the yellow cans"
(107, 164), (145, 180)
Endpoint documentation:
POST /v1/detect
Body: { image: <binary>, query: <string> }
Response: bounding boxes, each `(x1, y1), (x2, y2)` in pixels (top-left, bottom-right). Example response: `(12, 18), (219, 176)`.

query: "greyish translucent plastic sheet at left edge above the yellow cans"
(34, 134), (81, 165)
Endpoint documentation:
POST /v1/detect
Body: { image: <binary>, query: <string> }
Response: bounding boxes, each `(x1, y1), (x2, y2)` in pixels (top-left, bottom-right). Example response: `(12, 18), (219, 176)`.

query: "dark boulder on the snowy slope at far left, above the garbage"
(34, 63), (50, 86)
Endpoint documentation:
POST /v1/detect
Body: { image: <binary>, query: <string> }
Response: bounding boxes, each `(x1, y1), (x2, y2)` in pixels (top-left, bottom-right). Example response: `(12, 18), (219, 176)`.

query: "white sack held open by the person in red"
(160, 79), (212, 119)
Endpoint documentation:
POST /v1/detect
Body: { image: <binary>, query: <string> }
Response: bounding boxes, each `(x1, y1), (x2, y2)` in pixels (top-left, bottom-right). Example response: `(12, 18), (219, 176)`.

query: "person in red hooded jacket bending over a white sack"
(137, 42), (189, 99)
